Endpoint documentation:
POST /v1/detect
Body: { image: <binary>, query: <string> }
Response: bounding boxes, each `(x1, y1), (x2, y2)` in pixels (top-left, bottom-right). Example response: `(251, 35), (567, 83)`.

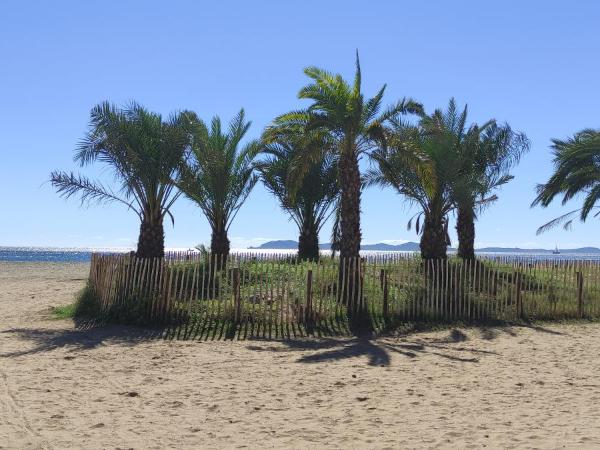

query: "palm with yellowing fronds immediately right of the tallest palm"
(366, 112), (460, 259)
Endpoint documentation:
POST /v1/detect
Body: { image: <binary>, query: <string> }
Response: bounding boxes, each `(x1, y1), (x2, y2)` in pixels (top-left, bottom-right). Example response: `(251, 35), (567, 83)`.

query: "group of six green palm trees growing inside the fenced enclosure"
(51, 55), (528, 268)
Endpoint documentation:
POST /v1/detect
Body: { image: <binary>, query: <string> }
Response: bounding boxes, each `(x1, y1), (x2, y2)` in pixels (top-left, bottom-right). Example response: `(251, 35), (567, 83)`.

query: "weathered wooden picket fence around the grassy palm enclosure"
(89, 253), (600, 337)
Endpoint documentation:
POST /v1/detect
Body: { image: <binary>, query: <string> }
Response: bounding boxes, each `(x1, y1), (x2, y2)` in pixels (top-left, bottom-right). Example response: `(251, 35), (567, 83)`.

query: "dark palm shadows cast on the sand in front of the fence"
(0, 314), (565, 366)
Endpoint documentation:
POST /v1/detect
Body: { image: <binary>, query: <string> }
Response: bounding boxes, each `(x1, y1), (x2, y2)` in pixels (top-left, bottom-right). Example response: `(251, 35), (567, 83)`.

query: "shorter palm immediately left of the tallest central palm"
(257, 127), (339, 260)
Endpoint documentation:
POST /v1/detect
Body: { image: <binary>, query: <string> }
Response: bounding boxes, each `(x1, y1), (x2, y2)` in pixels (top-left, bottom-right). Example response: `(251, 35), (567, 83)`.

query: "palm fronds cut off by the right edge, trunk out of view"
(531, 129), (600, 234)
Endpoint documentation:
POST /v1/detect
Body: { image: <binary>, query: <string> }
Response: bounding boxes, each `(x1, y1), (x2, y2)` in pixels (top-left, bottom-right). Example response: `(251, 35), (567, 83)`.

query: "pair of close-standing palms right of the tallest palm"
(367, 99), (529, 259)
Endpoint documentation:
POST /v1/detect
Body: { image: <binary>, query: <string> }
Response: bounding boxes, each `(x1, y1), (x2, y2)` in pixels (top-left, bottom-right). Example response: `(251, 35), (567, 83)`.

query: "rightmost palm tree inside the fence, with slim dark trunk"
(423, 98), (529, 259)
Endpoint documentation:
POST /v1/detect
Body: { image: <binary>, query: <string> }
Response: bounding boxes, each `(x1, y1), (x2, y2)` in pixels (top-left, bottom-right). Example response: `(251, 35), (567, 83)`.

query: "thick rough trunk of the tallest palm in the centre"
(338, 151), (364, 326)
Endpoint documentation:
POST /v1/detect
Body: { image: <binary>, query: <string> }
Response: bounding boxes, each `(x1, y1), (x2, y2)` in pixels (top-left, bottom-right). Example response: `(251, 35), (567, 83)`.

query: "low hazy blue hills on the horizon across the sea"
(248, 240), (600, 254)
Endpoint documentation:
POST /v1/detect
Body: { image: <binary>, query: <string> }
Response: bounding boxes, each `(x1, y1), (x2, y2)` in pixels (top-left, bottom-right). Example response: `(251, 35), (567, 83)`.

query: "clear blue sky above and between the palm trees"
(0, 0), (600, 248)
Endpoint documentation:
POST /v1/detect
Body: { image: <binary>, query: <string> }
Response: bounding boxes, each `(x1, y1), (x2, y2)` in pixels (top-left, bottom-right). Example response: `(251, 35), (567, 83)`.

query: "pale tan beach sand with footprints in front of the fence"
(0, 263), (600, 449)
